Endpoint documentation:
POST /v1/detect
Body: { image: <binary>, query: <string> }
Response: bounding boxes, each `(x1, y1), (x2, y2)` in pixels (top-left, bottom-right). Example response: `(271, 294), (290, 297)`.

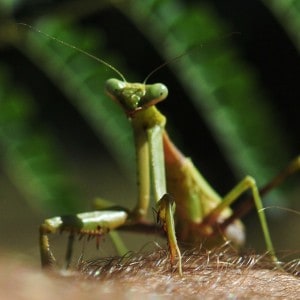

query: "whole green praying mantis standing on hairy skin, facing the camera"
(29, 25), (300, 275)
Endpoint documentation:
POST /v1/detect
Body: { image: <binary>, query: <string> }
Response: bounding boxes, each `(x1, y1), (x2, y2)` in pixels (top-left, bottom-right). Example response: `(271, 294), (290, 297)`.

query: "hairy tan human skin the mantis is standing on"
(0, 246), (300, 300)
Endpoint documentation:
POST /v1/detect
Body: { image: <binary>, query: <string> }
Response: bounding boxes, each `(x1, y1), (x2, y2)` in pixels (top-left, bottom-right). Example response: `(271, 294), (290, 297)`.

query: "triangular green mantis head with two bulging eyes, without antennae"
(105, 78), (168, 116)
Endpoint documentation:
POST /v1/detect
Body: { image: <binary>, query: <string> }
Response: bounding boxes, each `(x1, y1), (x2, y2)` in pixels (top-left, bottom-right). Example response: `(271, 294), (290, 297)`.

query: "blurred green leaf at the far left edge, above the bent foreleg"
(0, 68), (82, 214)
